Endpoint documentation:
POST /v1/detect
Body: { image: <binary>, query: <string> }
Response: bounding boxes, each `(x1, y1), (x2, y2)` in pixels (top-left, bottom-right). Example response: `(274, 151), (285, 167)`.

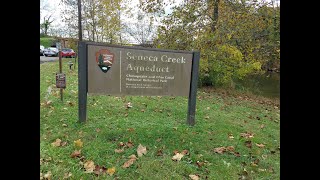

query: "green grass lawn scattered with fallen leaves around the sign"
(40, 59), (280, 180)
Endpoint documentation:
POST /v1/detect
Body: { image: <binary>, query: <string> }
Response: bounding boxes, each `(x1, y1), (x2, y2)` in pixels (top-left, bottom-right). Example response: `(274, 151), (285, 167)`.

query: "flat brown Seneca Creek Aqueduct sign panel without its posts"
(87, 45), (192, 96)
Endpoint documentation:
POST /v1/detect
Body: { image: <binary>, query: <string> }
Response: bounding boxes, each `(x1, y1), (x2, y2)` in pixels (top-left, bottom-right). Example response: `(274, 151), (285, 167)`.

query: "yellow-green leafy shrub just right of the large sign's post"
(199, 44), (261, 87)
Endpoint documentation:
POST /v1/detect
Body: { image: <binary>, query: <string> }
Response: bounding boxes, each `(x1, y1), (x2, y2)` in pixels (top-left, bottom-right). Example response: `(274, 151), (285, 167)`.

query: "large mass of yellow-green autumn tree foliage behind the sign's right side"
(143, 0), (280, 86)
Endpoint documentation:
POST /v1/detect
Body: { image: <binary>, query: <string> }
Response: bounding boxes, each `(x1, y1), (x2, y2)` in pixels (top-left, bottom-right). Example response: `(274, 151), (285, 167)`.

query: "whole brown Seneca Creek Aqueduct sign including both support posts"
(78, 41), (200, 125)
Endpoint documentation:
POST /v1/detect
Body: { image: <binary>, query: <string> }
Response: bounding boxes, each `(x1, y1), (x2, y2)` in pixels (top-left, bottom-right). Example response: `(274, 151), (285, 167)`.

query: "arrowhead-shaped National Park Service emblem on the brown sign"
(96, 49), (114, 73)
